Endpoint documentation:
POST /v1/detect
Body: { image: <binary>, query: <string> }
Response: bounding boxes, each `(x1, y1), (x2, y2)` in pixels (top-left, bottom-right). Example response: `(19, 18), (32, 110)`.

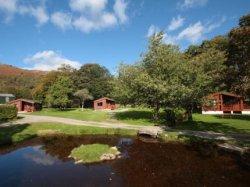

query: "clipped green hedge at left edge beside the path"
(0, 105), (17, 121)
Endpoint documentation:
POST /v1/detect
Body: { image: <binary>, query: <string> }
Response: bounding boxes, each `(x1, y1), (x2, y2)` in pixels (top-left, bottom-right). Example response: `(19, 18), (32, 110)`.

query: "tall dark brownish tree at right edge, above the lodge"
(226, 14), (250, 98)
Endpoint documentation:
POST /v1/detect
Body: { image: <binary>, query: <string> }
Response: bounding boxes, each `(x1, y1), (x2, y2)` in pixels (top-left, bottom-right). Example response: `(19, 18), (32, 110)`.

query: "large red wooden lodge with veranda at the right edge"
(202, 92), (250, 114)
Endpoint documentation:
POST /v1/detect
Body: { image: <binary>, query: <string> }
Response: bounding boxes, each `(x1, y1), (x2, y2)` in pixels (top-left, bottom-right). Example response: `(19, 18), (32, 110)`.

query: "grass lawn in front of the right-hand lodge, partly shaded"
(174, 114), (250, 133)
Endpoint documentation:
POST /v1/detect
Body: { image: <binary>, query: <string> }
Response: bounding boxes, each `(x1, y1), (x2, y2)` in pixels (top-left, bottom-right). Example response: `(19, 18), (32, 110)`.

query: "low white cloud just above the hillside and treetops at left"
(24, 50), (81, 71)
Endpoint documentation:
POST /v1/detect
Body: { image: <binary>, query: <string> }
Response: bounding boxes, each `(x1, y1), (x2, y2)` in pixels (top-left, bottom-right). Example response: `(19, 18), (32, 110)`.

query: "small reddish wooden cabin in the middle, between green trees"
(94, 97), (116, 110)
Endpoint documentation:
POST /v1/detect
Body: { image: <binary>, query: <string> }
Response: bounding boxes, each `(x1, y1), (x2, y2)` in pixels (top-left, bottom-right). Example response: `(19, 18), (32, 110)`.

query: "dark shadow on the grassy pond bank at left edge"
(0, 124), (35, 146)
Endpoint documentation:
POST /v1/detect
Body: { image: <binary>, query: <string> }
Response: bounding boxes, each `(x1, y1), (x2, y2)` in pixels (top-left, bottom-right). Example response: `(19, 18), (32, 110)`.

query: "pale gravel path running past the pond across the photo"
(1, 114), (250, 144)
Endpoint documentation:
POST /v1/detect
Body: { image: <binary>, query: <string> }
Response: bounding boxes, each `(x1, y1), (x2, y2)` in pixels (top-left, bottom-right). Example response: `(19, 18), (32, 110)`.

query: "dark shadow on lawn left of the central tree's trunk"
(113, 111), (165, 124)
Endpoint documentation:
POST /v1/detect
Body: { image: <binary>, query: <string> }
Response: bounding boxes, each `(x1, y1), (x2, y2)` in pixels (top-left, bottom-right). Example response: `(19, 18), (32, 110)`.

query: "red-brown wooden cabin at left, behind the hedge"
(9, 99), (42, 112)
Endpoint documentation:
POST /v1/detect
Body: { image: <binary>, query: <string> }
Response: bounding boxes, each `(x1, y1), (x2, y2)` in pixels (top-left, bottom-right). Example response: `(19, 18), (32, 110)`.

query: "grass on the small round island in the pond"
(70, 144), (119, 163)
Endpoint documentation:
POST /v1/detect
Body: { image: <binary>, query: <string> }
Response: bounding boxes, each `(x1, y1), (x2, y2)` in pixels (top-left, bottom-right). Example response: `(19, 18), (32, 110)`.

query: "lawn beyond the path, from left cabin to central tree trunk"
(31, 108), (159, 125)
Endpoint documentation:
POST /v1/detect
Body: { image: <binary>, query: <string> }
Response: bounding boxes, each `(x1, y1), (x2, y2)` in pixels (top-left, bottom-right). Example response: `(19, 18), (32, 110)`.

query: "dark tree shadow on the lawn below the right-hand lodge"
(174, 121), (249, 133)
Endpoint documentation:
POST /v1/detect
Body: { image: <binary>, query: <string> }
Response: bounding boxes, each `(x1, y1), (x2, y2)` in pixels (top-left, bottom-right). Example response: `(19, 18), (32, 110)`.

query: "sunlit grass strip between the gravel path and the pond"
(0, 123), (137, 145)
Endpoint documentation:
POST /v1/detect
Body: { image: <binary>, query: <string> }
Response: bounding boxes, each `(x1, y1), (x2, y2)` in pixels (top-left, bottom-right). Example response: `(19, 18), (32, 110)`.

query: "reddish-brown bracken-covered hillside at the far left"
(0, 64), (46, 99)
